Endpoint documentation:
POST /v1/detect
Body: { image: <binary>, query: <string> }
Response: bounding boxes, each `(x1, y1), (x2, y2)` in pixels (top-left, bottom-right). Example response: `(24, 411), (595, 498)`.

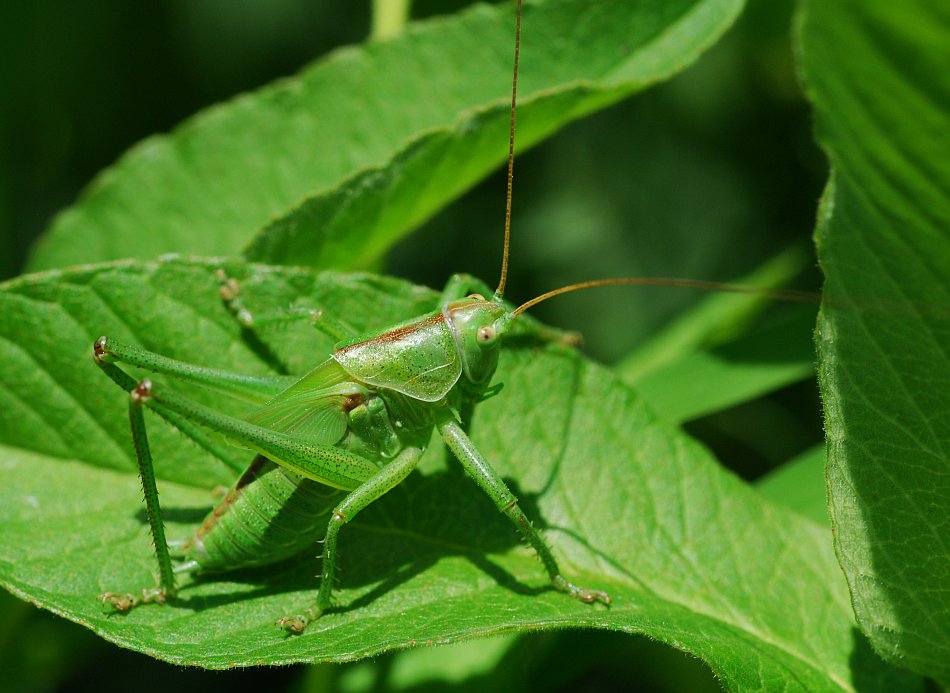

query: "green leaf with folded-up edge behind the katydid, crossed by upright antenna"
(30, 0), (743, 270)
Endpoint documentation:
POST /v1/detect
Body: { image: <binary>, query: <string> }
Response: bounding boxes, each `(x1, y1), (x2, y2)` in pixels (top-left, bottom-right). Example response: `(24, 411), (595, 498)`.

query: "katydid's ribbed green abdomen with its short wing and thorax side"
(178, 359), (433, 572)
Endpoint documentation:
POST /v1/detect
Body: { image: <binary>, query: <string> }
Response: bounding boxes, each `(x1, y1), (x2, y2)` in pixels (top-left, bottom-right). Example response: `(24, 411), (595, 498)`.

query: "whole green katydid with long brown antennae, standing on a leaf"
(94, 0), (812, 633)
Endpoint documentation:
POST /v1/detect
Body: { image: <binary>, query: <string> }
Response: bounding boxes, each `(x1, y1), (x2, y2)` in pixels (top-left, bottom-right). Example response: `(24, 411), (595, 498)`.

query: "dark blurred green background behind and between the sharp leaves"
(0, 0), (826, 693)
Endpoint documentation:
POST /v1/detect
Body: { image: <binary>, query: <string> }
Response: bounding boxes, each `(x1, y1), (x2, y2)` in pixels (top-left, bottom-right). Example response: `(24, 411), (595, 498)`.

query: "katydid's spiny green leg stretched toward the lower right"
(437, 418), (610, 604)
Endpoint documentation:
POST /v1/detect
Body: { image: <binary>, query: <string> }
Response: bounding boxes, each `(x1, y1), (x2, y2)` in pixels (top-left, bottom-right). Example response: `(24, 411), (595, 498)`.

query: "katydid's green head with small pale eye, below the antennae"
(443, 294), (509, 385)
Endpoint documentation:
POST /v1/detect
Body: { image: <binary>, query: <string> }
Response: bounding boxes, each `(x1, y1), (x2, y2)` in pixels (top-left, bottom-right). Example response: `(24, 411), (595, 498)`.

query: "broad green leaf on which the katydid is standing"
(0, 259), (913, 690)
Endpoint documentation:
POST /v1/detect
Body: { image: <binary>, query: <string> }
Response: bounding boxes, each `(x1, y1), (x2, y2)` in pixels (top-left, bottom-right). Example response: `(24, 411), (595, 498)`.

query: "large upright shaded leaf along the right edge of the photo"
(800, 0), (950, 685)
